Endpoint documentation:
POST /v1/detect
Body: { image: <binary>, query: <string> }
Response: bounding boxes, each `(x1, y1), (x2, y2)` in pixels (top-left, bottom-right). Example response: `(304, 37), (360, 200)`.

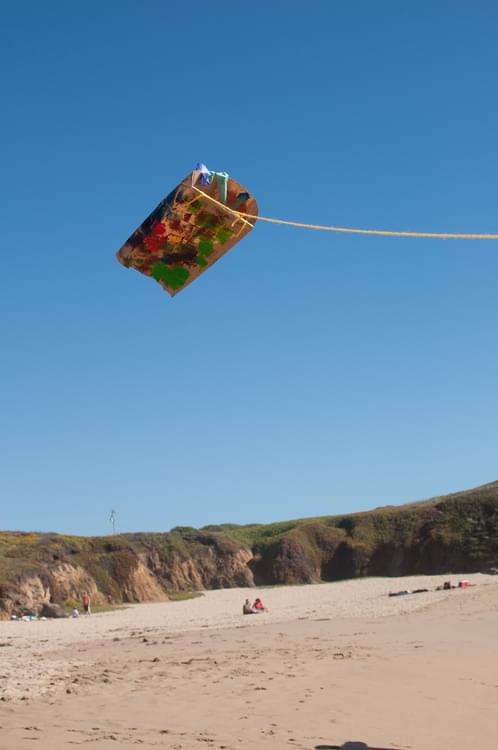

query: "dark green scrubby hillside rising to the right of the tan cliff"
(205, 482), (498, 583)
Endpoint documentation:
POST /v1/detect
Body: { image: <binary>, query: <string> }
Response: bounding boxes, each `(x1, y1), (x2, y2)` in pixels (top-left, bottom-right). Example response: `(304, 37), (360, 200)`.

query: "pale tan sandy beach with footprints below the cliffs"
(0, 575), (498, 750)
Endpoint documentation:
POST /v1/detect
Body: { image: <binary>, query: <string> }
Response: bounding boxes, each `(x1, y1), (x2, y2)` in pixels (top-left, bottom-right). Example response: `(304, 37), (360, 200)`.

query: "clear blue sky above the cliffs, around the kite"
(0, 0), (498, 534)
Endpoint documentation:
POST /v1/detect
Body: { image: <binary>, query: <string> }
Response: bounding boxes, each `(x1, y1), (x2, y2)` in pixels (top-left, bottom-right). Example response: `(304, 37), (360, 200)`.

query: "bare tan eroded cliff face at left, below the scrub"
(0, 534), (254, 618)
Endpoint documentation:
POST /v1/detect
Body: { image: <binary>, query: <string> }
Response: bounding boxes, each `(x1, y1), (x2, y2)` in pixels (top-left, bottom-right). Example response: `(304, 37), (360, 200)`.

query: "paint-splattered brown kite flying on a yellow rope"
(116, 163), (258, 296)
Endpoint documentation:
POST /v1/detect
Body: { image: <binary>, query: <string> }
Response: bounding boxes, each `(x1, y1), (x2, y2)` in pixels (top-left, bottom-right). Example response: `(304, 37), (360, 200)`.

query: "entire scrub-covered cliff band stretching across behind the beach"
(0, 482), (498, 618)
